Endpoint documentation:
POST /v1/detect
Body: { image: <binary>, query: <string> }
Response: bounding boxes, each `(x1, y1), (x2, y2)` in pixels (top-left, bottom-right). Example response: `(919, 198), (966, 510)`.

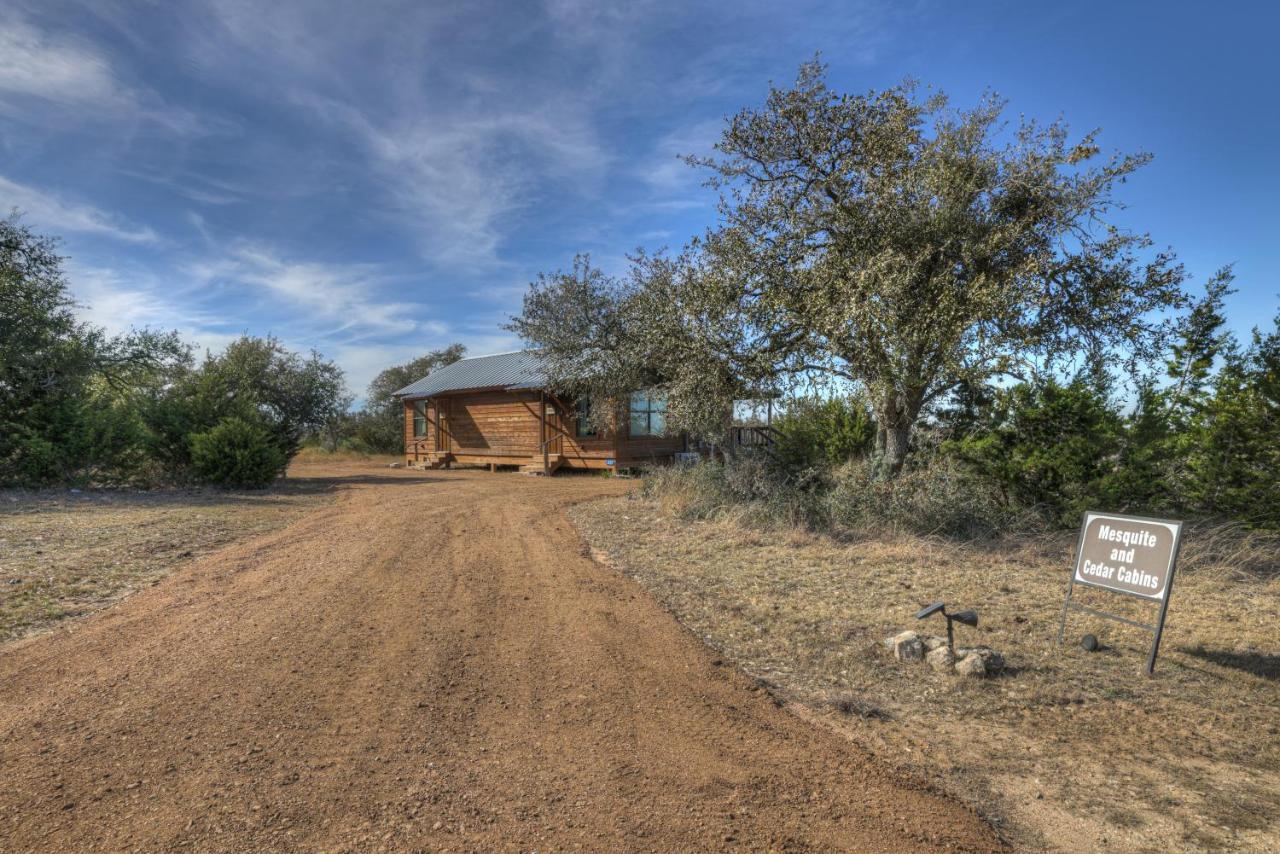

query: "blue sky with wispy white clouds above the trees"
(0, 0), (1280, 402)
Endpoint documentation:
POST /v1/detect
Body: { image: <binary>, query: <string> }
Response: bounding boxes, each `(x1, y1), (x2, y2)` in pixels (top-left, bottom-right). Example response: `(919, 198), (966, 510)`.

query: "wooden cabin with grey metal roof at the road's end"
(397, 351), (687, 474)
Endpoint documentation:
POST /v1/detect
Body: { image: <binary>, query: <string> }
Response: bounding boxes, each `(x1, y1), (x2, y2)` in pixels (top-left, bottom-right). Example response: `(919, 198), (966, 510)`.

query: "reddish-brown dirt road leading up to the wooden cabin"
(0, 465), (997, 851)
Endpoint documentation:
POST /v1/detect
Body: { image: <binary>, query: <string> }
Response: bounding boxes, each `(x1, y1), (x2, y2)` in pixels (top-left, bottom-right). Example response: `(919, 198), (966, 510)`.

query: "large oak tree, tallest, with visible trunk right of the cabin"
(690, 61), (1185, 472)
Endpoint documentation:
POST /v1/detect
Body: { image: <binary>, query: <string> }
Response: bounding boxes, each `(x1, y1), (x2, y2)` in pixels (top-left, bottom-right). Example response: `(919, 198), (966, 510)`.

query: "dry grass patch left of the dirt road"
(0, 480), (330, 641)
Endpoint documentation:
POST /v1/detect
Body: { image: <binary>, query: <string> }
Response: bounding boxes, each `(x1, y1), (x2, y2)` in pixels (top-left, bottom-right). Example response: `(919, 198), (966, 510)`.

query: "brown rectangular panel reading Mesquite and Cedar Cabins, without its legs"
(1074, 512), (1183, 602)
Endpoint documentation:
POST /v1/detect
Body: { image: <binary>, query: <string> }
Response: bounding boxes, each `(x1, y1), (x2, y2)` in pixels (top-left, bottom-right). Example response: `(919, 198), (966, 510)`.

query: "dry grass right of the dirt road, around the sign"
(573, 498), (1280, 850)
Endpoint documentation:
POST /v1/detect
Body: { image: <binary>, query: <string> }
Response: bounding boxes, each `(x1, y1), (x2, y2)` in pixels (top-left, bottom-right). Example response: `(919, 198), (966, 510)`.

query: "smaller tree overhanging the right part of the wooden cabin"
(508, 252), (780, 442)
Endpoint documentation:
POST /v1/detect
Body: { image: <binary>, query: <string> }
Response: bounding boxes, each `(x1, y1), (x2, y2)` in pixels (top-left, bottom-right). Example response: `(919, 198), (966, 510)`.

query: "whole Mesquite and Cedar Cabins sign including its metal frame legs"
(1057, 511), (1183, 676)
